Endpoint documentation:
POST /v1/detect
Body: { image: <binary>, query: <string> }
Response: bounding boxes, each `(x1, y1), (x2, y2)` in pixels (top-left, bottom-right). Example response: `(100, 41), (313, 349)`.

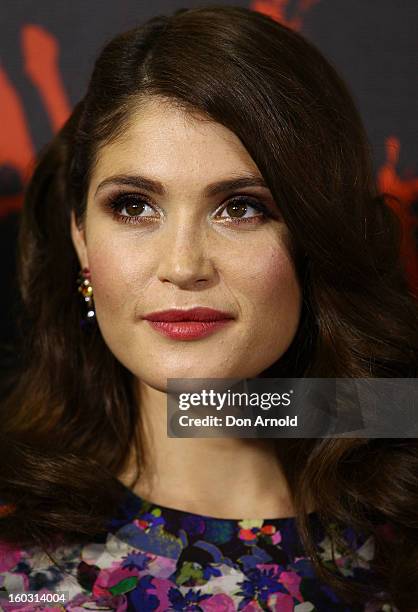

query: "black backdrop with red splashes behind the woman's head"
(0, 0), (418, 367)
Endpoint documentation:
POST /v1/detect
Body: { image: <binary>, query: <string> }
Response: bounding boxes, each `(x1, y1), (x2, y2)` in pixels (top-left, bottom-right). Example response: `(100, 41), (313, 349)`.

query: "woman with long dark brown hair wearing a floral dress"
(0, 6), (418, 612)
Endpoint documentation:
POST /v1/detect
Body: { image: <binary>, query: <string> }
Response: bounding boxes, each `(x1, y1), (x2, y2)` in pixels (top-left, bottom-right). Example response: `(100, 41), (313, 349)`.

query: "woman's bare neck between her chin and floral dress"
(119, 382), (294, 519)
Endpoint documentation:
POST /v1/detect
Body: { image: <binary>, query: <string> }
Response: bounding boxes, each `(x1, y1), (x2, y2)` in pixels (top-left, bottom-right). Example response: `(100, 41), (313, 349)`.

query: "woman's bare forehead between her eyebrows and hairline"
(91, 101), (261, 196)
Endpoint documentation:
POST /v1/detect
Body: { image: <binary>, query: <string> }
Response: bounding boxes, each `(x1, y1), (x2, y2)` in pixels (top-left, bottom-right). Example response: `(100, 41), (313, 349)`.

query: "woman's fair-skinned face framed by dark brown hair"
(71, 98), (302, 391)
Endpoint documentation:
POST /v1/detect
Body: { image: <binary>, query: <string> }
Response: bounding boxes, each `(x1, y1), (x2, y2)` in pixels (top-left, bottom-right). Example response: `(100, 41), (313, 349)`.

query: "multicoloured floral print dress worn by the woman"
(0, 488), (399, 612)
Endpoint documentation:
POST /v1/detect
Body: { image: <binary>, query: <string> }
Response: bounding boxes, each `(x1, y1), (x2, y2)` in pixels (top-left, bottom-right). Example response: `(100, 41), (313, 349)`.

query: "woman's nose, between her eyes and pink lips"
(157, 222), (215, 289)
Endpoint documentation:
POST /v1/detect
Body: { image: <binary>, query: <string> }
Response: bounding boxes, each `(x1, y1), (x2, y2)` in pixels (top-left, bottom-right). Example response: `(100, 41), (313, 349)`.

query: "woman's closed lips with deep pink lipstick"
(143, 307), (233, 340)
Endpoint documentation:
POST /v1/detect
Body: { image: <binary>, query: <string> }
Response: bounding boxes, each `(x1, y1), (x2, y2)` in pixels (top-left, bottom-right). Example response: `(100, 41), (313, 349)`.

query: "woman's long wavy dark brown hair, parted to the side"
(0, 5), (418, 611)
